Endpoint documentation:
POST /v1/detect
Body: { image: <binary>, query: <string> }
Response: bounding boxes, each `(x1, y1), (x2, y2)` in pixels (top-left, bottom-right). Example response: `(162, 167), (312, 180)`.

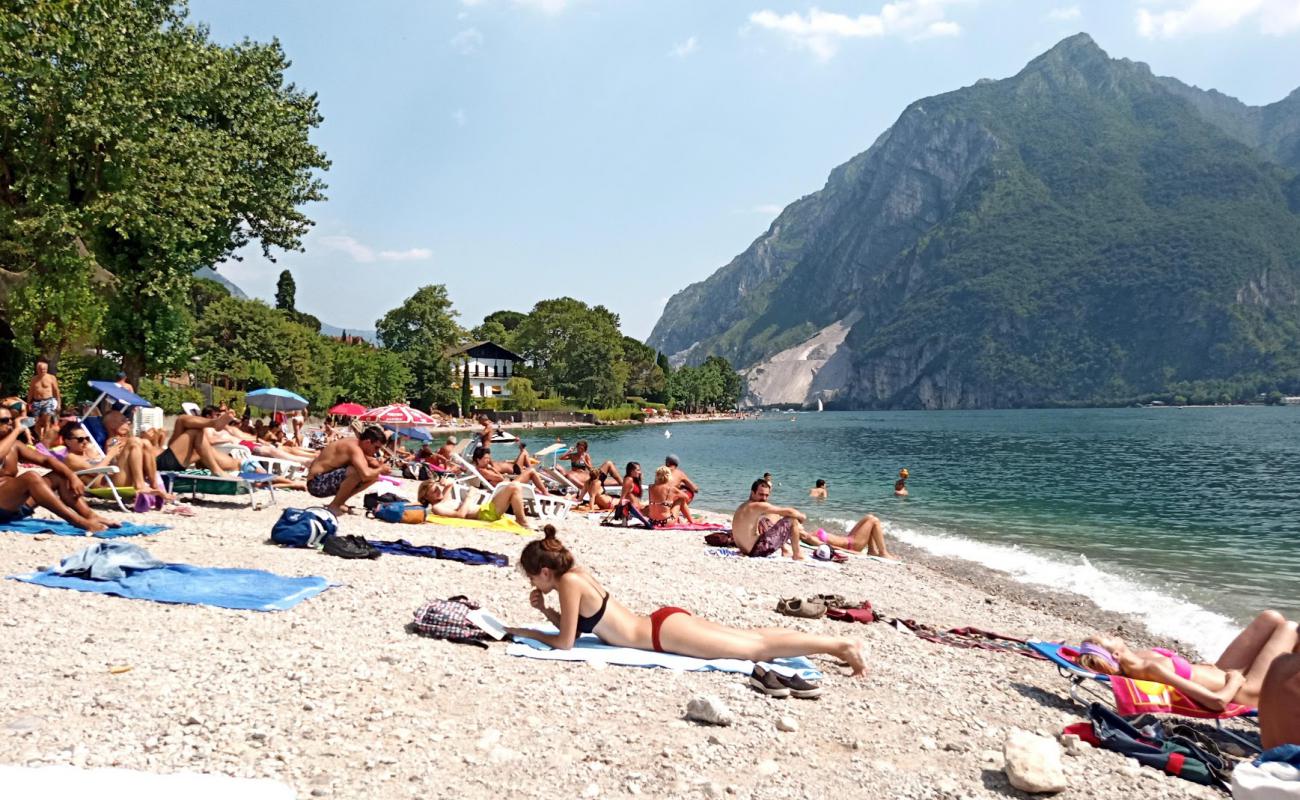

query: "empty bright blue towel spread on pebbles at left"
(9, 563), (333, 611)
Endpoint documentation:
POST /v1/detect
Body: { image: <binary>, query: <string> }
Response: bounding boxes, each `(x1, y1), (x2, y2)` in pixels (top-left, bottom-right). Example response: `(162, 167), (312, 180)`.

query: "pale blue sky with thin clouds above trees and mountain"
(191, 0), (1300, 338)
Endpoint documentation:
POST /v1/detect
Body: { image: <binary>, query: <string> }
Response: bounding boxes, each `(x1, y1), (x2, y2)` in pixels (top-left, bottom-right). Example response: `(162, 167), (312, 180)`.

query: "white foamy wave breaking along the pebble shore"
(835, 519), (1242, 660)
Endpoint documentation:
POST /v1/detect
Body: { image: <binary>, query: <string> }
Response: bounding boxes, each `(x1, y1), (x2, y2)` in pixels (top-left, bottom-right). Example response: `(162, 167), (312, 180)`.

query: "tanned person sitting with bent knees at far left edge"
(0, 408), (117, 535)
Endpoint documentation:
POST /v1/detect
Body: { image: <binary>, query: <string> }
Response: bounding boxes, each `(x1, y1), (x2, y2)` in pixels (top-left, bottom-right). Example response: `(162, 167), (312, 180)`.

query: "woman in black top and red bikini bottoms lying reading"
(506, 526), (867, 676)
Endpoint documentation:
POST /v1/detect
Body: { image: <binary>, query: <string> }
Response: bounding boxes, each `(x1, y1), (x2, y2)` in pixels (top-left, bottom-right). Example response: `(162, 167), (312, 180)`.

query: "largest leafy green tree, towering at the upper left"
(0, 0), (328, 377)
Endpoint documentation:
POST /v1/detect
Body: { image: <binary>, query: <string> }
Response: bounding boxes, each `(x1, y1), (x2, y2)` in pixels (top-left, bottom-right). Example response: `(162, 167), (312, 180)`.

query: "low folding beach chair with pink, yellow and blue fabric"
(1026, 640), (1260, 751)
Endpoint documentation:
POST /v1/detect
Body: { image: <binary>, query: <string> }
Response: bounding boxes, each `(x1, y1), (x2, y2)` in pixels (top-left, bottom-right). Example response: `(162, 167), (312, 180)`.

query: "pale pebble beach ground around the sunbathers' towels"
(0, 484), (1237, 800)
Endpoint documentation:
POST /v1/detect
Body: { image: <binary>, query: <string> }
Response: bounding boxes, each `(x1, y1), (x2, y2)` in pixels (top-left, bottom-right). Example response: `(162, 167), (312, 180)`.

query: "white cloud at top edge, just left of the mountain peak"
(749, 0), (962, 61)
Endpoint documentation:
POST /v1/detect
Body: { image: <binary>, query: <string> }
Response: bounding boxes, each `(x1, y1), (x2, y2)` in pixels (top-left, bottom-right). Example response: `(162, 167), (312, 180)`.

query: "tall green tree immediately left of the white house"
(374, 284), (463, 408)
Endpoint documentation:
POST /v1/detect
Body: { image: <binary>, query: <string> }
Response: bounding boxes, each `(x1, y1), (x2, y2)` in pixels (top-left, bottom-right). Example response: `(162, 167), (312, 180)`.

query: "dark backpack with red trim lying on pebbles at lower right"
(1065, 702), (1231, 790)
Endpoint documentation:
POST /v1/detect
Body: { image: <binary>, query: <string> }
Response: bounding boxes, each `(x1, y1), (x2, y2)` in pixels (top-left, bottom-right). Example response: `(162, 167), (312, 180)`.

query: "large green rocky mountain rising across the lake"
(647, 34), (1300, 408)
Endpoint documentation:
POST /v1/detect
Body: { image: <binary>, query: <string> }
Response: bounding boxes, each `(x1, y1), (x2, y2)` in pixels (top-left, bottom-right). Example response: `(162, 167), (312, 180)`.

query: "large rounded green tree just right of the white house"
(515, 298), (628, 407)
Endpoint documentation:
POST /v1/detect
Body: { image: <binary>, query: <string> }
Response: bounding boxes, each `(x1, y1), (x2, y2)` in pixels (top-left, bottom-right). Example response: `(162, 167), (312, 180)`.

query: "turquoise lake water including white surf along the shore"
(525, 407), (1300, 656)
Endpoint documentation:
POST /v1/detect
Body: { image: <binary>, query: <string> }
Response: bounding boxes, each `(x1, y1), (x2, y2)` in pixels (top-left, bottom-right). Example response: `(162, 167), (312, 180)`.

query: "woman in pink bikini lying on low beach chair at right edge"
(1079, 611), (1296, 712)
